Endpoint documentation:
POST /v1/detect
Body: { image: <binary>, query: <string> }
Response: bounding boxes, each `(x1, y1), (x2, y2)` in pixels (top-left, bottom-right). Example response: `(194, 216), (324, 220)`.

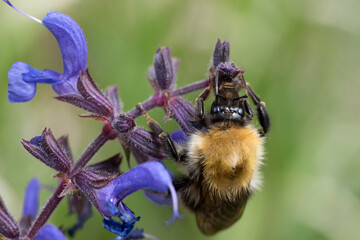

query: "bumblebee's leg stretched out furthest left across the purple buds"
(136, 104), (180, 161)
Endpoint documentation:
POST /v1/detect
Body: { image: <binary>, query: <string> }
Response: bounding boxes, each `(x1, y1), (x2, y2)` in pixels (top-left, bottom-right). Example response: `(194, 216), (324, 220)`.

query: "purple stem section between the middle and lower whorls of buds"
(70, 131), (109, 175)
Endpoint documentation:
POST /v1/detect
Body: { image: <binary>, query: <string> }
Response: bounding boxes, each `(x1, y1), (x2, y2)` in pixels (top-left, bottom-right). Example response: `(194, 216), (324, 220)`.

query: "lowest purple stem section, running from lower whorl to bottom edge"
(28, 180), (65, 239)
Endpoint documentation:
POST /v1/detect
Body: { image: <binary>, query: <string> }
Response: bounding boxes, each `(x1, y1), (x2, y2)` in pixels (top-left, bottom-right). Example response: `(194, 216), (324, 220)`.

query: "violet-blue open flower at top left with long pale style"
(5, 1), (87, 102)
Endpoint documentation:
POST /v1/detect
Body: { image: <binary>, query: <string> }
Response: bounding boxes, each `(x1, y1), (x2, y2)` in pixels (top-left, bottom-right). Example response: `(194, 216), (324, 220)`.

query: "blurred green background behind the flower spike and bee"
(0, 0), (360, 240)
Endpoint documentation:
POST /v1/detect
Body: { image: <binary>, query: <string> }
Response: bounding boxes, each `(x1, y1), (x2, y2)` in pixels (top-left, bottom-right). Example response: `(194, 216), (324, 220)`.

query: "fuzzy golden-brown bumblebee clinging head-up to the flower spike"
(141, 50), (270, 235)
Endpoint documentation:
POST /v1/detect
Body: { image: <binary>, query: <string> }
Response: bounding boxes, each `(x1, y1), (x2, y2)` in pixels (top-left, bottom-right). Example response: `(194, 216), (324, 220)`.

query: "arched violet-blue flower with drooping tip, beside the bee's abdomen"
(97, 161), (181, 237)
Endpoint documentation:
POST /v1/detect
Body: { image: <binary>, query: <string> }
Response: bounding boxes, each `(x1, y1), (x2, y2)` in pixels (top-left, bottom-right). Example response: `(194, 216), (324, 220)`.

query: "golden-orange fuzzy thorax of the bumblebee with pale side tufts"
(187, 126), (263, 199)
